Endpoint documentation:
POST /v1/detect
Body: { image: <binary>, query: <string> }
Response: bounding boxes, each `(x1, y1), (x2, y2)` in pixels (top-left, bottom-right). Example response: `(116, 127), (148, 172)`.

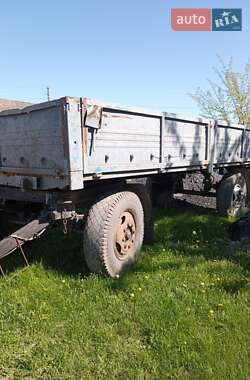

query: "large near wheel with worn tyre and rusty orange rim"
(84, 191), (144, 278)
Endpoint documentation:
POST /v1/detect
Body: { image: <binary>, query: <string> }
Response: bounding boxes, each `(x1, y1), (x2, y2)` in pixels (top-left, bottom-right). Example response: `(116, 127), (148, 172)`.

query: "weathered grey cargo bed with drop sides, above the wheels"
(0, 97), (250, 190)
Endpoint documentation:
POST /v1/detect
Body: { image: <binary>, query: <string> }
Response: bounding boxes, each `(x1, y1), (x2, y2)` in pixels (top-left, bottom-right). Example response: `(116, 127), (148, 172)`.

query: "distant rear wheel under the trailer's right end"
(216, 173), (247, 216)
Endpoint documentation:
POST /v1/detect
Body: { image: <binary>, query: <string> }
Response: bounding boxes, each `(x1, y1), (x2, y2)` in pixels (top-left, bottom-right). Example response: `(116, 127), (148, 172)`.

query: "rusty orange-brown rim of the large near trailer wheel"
(115, 211), (136, 260)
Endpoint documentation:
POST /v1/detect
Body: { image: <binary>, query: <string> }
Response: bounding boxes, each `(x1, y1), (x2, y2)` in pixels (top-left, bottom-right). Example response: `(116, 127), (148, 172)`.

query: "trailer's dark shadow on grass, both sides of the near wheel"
(0, 201), (250, 288)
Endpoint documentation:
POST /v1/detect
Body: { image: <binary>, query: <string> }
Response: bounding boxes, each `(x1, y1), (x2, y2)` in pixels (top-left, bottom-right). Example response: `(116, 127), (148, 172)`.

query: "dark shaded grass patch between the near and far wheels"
(152, 202), (250, 284)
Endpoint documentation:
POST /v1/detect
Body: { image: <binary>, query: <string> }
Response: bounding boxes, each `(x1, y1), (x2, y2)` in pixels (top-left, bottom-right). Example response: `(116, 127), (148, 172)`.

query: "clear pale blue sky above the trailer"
(0, 0), (250, 115)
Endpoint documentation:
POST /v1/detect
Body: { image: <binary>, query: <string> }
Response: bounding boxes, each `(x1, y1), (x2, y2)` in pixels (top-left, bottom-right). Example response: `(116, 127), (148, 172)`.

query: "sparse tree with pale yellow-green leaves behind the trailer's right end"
(190, 57), (250, 125)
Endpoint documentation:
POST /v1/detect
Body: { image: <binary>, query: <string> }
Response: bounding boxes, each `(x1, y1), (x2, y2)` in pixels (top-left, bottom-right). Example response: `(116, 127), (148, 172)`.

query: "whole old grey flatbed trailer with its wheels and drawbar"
(0, 97), (250, 277)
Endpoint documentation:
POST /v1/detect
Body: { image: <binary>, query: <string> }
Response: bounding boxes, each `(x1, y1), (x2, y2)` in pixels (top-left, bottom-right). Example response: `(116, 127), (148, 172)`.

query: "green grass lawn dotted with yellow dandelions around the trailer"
(0, 200), (250, 380)
